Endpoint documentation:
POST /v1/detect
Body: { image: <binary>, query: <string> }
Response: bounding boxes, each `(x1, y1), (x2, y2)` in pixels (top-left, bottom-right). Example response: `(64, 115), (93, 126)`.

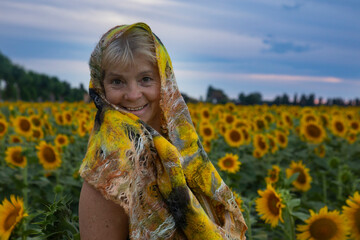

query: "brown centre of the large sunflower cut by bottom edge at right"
(309, 218), (338, 240)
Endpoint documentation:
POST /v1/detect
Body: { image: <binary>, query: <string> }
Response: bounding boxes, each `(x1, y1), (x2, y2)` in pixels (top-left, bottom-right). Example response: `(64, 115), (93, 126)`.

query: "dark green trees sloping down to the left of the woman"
(0, 52), (86, 102)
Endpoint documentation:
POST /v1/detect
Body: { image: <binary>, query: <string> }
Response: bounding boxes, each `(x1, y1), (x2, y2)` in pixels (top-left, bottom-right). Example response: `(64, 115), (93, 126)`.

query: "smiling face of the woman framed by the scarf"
(104, 54), (161, 131)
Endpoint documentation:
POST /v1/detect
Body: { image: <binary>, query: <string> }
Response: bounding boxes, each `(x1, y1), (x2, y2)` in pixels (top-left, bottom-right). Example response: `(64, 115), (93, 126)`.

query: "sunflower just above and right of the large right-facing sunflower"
(286, 161), (312, 192)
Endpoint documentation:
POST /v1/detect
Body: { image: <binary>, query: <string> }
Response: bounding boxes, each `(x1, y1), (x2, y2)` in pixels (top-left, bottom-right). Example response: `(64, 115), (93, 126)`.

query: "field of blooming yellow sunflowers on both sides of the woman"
(0, 102), (360, 240)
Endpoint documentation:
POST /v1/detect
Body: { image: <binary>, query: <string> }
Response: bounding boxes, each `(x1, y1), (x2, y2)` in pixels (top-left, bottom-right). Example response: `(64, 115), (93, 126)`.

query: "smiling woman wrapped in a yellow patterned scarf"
(79, 23), (247, 240)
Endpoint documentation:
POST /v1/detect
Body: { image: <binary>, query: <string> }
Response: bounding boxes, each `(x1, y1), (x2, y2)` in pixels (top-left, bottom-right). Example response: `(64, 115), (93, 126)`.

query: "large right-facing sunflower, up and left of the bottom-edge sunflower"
(255, 184), (285, 227)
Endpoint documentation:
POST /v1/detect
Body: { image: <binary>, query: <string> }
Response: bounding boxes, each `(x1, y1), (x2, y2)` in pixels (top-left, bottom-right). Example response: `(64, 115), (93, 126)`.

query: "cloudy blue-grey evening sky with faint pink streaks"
(0, 0), (360, 100)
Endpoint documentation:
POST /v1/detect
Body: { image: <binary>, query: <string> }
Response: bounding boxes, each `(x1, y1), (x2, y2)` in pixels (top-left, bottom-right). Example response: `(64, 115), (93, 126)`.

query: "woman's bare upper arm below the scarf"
(79, 181), (129, 240)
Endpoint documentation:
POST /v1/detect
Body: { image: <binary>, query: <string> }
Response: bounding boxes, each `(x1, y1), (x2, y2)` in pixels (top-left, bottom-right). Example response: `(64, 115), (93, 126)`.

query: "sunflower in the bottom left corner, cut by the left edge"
(0, 195), (28, 240)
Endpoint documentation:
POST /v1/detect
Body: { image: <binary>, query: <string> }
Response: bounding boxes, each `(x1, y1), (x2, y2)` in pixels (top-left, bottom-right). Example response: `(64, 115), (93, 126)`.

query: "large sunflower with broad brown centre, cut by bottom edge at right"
(296, 206), (347, 240)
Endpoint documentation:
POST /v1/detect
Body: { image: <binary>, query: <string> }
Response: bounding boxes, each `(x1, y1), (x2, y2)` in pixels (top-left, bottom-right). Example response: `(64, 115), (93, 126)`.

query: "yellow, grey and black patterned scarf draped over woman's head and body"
(80, 23), (247, 240)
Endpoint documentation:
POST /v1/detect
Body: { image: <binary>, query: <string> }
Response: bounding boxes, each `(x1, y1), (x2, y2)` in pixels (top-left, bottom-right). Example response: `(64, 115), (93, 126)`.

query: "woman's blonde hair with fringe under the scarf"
(101, 27), (156, 70)
